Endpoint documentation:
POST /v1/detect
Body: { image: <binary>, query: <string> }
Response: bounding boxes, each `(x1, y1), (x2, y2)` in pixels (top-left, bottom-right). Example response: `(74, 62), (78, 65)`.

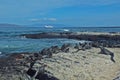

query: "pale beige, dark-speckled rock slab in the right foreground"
(42, 48), (120, 80)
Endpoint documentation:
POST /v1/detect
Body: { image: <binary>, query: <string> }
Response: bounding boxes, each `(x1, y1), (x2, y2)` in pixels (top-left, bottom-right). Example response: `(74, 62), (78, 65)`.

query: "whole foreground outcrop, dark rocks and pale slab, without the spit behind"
(0, 41), (120, 80)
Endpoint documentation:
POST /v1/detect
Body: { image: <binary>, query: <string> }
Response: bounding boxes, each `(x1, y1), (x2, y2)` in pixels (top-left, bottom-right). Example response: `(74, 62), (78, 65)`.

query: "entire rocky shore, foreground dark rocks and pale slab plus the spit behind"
(0, 33), (120, 80)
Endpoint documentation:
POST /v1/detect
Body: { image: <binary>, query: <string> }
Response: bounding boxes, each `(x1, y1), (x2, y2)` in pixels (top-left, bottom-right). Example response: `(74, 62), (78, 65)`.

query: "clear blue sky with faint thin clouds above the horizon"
(0, 0), (120, 27)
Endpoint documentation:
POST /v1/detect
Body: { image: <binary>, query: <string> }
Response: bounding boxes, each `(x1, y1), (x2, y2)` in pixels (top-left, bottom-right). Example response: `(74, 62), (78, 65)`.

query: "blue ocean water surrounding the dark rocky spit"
(0, 27), (120, 54)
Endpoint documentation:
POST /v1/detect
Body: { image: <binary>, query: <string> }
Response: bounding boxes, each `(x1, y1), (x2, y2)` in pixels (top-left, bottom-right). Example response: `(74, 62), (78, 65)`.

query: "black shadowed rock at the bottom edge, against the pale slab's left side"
(26, 63), (58, 80)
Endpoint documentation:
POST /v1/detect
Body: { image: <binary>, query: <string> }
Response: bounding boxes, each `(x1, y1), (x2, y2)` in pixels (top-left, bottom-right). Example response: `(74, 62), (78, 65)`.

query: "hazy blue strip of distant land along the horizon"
(0, 23), (120, 28)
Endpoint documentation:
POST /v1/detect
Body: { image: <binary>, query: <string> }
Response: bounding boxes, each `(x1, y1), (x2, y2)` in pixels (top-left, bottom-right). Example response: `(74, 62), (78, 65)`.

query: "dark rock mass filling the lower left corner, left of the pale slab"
(0, 53), (58, 80)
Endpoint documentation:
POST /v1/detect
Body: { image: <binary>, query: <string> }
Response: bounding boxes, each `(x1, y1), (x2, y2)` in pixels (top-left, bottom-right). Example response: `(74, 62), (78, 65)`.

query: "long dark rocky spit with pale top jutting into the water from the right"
(20, 32), (120, 47)
